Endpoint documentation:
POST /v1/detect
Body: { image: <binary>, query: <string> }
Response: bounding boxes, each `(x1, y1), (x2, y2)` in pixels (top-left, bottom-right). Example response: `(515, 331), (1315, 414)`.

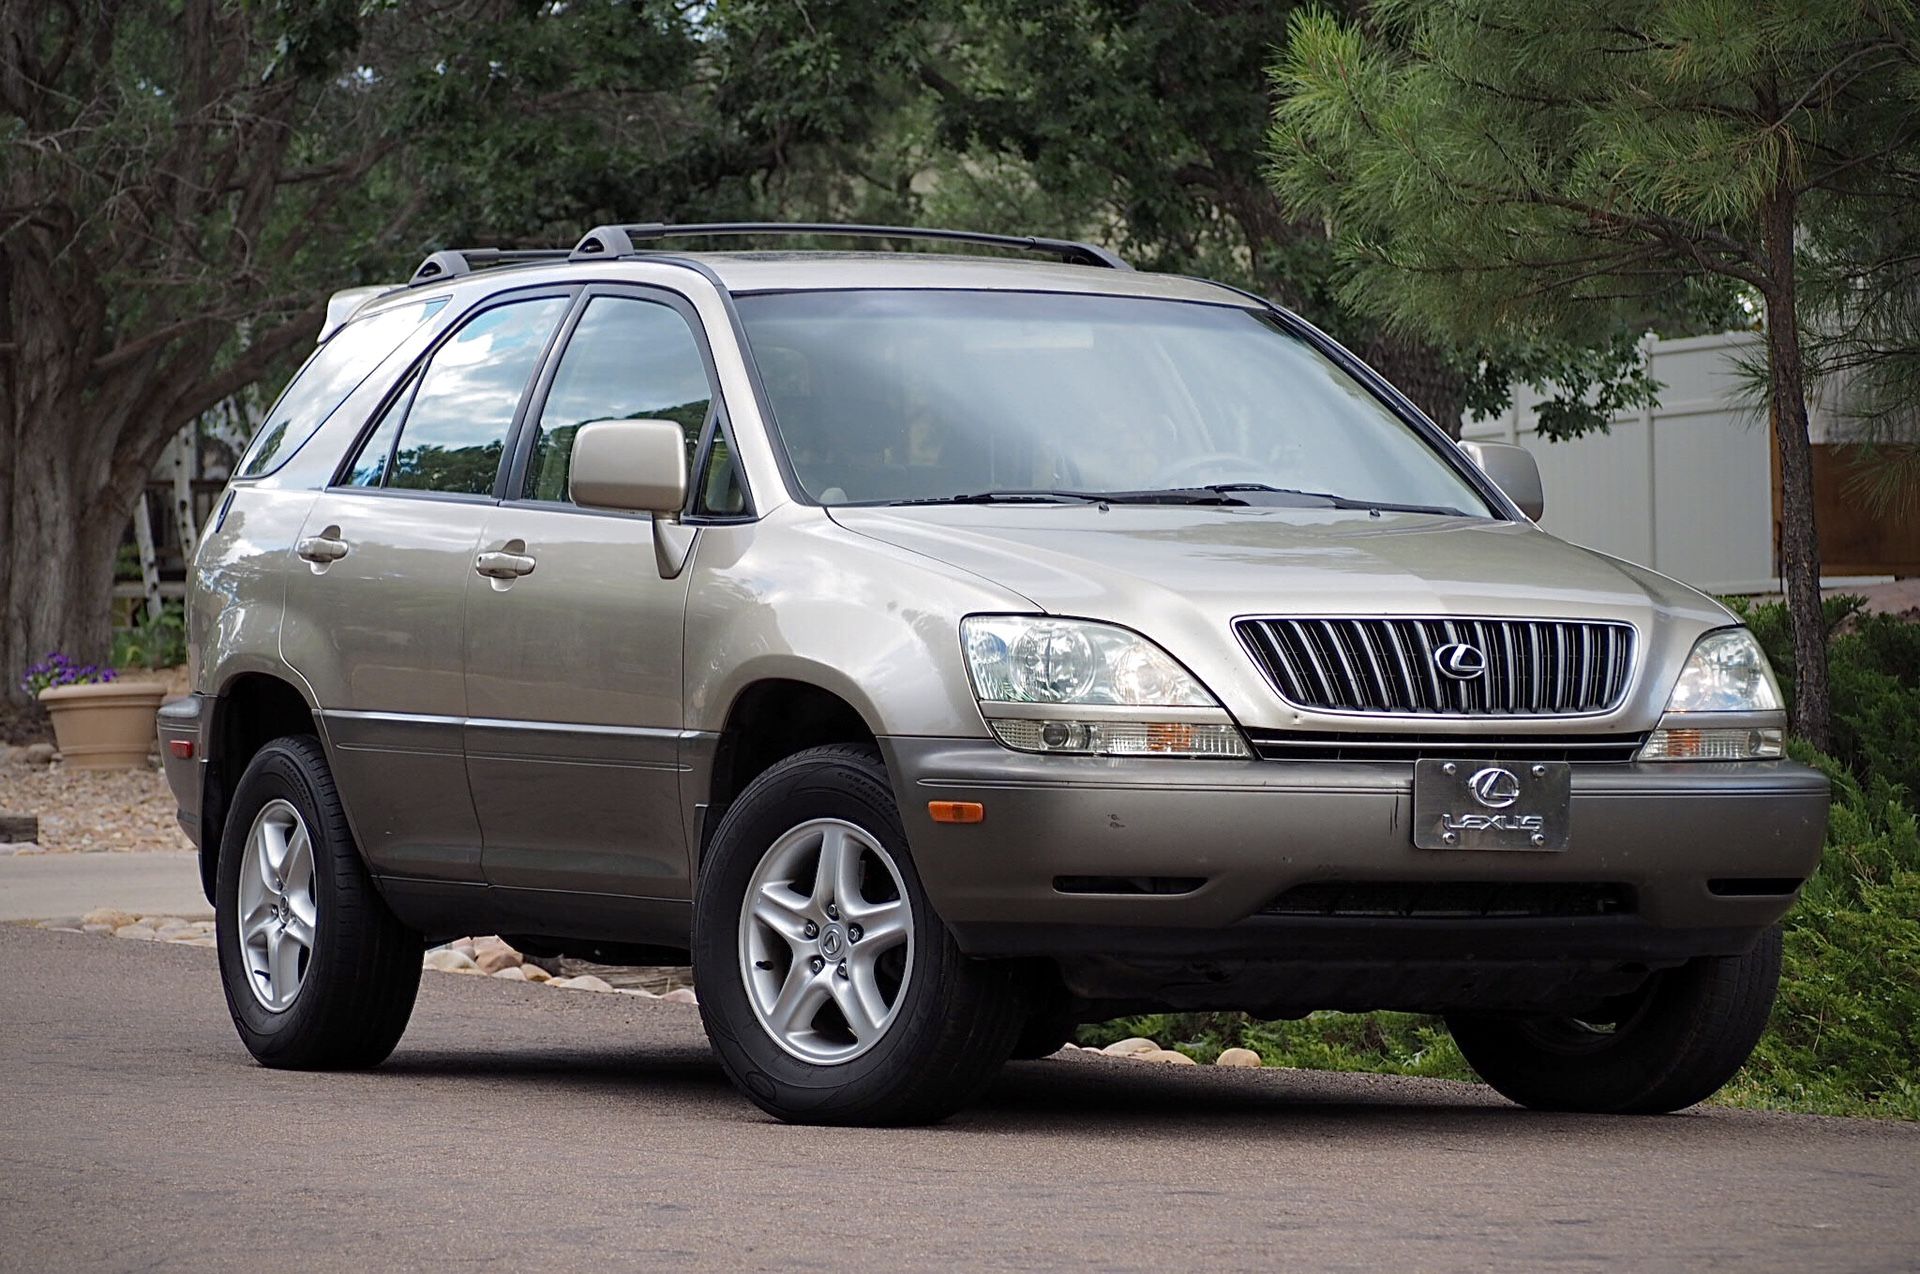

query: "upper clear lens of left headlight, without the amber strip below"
(960, 616), (1217, 708)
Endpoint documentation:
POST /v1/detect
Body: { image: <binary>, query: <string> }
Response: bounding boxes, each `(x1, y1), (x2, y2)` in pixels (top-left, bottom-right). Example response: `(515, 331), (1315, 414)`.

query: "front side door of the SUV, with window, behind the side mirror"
(467, 288), (714, 900)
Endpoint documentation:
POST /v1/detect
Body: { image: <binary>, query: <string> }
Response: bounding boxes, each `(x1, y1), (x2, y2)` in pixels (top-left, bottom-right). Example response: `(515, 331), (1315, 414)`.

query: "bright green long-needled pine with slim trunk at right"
(1271, 0), (1920, 746)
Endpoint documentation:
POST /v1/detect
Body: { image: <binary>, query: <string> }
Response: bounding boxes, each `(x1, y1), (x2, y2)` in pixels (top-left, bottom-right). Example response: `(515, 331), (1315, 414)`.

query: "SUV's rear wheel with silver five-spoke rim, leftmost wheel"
(215, 735), (420, 1071)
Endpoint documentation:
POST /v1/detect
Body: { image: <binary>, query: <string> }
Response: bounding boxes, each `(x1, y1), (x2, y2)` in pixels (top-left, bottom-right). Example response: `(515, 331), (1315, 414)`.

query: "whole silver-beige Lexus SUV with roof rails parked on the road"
(161, 224), (1828, 1122)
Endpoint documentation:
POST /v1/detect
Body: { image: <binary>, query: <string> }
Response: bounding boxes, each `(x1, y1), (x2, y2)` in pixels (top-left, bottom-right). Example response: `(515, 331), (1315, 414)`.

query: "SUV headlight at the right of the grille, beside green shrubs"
(1640, 627), (1786, 762)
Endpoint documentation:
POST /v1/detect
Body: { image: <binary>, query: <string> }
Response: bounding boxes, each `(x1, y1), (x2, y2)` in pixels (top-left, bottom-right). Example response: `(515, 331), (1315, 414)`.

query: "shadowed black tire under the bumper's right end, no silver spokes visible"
(1446, 927), (1780, 1115)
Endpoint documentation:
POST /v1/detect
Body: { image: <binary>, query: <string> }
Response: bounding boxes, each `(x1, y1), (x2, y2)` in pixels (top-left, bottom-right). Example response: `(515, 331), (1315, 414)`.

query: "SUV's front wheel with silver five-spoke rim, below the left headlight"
(693, 744), (1023, 1124)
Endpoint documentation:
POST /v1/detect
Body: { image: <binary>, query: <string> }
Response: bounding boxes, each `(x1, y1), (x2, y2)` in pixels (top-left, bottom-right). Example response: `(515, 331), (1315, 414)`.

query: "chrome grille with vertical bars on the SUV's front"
(1235, 618), (1634, 716)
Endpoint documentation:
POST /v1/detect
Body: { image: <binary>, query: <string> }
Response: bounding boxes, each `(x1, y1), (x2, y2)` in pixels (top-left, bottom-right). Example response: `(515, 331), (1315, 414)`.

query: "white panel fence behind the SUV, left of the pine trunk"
(1461, 332), (1822, 593)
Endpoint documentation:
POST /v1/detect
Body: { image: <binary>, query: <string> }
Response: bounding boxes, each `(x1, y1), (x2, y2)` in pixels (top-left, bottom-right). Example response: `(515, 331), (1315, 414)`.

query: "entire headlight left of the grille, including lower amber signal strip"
(960, 616), (1250, 758)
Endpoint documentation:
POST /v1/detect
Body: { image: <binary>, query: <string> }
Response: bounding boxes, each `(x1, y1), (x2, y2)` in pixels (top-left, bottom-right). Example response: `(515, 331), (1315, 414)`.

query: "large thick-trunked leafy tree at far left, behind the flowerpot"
(0, 0), (779, 687)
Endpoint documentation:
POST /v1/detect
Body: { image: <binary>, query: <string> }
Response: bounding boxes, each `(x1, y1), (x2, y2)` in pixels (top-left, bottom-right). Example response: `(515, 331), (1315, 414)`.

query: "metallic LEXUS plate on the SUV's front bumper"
(1413, 758), (1572, 852)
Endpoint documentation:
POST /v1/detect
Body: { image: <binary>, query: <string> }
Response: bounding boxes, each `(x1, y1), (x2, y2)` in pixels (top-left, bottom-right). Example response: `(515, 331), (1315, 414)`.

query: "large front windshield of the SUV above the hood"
(739, 290), (1490, 516)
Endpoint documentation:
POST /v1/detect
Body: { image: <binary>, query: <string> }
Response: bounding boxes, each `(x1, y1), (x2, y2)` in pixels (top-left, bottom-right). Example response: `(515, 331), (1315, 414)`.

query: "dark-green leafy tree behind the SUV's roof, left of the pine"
(724, 0), (1697, 434)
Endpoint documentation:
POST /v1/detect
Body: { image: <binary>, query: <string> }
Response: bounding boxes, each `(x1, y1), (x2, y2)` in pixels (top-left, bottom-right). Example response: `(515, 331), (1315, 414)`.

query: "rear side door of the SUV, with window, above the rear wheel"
(280, 290), (572, 881)
